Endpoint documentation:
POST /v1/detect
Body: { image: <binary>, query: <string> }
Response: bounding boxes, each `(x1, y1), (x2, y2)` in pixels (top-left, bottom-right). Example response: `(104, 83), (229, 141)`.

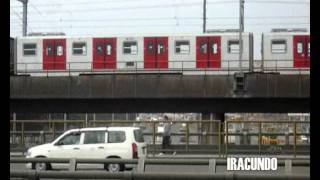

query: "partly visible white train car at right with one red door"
(261, 31), (310, 74)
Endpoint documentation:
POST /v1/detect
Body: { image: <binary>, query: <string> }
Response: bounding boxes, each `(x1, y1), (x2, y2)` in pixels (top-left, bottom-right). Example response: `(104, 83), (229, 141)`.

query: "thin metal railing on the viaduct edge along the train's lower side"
(13, 60), (310, 76)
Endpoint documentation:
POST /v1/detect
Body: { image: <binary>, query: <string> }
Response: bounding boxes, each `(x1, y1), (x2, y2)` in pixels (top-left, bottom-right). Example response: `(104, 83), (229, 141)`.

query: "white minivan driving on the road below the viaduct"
(26, 127), (146, 172)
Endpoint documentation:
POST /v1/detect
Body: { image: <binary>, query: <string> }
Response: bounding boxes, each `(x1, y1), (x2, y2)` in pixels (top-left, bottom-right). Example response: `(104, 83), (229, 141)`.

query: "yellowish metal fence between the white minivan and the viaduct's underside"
(10, 120), (310, 157)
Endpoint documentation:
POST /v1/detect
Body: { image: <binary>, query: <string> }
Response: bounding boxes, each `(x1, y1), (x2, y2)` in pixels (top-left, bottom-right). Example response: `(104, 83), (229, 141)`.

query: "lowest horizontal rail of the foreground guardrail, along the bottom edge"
(10, 171), (310, 180)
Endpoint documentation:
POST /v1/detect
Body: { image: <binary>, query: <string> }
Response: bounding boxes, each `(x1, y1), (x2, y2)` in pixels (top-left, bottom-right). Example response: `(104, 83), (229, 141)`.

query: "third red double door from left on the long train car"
(144, 37), (168, 69)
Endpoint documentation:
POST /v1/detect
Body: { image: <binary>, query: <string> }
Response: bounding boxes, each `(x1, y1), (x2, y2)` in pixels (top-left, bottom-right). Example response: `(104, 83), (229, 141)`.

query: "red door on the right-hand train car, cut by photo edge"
(293, 35), (310, 68)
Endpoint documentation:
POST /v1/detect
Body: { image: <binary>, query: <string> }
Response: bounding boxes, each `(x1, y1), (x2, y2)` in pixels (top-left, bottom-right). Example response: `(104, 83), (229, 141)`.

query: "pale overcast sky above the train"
(10, 0), (310, 58)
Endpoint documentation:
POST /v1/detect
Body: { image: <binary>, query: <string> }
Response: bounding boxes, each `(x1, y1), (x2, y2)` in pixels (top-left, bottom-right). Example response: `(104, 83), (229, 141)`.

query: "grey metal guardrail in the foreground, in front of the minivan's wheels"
(10, 158), (310, 180)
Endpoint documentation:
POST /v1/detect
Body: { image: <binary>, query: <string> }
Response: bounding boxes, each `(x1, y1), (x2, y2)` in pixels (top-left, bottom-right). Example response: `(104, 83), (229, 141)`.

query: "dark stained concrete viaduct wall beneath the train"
(10, 74), (310, 113)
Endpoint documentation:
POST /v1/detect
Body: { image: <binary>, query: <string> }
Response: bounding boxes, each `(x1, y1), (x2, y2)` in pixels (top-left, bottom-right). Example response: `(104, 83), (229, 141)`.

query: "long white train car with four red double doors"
(16, 33), (253, 76)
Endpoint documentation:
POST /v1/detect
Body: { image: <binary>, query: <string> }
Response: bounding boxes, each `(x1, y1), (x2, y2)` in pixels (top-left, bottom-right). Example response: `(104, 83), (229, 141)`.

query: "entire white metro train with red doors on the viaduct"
(13, 28), (310, 76)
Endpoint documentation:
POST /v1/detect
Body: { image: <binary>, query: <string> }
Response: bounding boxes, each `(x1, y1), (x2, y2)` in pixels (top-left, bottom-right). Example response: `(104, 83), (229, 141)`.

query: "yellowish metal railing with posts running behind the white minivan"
(10, 120), (310, 157)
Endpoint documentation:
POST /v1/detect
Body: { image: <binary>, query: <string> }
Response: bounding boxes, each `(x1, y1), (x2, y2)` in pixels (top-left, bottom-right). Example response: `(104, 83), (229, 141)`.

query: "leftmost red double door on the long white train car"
(43, 39), (66, 70)
